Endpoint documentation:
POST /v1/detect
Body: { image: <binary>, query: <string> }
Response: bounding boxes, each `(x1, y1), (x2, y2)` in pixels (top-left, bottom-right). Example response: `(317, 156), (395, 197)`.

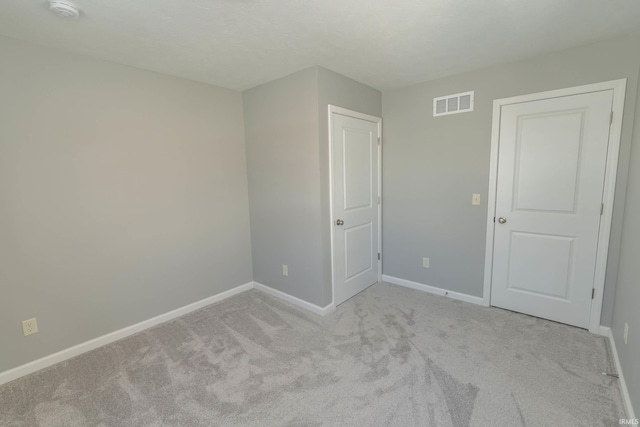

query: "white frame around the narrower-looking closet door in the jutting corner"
(328, 104), (382, 308)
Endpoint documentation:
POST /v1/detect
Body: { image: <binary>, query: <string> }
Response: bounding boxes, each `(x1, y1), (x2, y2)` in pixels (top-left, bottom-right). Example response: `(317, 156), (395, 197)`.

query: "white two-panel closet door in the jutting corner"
(331, 108), (380, 305)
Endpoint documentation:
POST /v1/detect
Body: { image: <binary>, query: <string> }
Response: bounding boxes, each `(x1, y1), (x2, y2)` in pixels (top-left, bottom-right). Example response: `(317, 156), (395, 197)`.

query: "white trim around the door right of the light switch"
(482, 79), (627, 333)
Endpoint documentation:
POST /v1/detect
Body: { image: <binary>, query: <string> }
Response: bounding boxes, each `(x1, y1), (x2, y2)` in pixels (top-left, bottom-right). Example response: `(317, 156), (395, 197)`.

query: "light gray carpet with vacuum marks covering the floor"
(0, 283), (626, 427)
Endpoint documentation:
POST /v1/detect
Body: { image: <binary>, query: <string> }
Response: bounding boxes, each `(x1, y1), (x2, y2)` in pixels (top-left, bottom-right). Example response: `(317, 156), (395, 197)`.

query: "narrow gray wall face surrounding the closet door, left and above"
(318, 67), (382, 304)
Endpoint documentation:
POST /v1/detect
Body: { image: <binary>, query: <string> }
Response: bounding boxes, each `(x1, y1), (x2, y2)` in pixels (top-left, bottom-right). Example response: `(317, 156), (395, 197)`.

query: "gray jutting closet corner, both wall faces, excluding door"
(243, 67), (382, 307)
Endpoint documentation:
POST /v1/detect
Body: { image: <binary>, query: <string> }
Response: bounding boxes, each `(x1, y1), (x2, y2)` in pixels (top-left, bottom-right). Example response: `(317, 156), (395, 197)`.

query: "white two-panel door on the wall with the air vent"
(491, 90), (613, 328)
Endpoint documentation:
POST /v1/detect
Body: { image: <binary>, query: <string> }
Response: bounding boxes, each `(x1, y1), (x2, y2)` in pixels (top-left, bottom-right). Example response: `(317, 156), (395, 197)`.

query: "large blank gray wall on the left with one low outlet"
(0, 38), (252, 371)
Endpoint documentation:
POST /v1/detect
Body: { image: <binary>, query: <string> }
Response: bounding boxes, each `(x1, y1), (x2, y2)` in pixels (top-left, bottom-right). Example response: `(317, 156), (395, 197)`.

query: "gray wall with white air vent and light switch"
(382, 35), (640, 310)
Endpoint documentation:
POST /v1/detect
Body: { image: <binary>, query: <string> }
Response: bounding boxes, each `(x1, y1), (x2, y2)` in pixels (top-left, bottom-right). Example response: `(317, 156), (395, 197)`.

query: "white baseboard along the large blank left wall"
(0, 282), (253, 385)
